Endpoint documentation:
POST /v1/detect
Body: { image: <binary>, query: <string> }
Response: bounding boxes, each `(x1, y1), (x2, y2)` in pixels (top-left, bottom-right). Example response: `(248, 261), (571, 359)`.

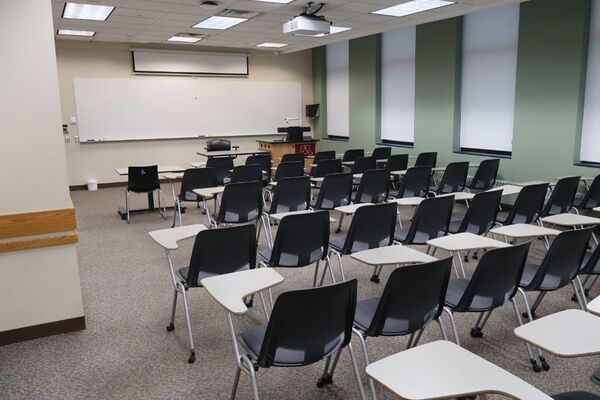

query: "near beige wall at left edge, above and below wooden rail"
(0, 0), (83, 331)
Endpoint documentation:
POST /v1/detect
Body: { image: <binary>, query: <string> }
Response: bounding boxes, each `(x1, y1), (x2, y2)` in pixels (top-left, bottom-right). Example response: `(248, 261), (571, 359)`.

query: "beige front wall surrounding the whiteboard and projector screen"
(56, 40), (313, 185)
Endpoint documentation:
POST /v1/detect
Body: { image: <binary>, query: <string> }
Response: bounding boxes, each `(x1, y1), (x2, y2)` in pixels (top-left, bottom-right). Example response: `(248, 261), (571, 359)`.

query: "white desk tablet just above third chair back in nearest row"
(427, 232), (510, 278)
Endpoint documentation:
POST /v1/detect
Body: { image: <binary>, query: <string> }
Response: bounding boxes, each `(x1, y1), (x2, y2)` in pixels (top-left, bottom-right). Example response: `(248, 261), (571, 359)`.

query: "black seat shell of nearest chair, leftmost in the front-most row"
(257, 279), (357, 368)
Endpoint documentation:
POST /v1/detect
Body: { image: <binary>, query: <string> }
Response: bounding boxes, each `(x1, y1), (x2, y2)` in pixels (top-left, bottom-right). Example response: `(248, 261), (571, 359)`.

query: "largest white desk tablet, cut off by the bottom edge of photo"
(367, 340), (552, 400)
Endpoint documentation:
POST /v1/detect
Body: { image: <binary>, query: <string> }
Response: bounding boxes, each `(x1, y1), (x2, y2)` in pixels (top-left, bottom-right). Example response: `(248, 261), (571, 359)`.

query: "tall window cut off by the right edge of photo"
(579, 0), (600, 163)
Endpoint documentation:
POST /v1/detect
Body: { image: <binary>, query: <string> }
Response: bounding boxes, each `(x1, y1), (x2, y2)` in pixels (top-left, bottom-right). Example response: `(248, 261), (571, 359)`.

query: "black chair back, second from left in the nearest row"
(366, 257), (452, 336)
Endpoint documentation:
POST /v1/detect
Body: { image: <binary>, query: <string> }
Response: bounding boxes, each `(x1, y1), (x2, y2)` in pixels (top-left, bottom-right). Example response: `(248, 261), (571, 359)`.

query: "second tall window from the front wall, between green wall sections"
(380, 26), (417, 146)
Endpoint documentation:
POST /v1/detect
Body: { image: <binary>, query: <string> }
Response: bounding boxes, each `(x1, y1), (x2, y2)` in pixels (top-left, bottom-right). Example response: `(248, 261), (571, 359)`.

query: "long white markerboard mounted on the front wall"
(73, 77), (302, 142)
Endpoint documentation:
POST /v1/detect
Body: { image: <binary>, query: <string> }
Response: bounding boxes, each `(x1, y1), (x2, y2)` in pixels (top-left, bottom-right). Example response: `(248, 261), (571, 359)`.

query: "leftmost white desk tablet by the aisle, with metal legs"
(148, 224), (207, 363)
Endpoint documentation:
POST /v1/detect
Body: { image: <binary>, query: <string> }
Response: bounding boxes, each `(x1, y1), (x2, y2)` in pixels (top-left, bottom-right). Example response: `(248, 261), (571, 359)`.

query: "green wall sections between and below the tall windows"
(313, 0), (599, 181)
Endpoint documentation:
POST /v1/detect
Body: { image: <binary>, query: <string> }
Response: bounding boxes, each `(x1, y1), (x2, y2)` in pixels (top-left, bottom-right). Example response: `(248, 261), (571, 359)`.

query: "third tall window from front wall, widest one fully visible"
(460, 4), (519, 156)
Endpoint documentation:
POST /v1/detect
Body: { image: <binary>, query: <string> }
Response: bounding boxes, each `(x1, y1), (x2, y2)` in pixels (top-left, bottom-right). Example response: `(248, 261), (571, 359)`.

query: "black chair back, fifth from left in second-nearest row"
(457, 190), (502, 235)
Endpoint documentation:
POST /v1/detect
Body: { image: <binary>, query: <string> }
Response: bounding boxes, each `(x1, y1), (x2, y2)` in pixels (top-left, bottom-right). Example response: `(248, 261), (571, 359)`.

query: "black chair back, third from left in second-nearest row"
(342, 203), (398, 254)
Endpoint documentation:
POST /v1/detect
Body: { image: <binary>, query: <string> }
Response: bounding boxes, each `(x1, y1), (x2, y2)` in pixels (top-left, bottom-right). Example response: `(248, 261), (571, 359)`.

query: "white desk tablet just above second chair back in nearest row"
(350, 245), (437, 282)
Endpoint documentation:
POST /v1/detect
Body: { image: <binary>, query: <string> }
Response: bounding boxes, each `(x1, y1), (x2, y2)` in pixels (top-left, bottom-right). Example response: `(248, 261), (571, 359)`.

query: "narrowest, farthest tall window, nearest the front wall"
(326, 41), (350, 139)
